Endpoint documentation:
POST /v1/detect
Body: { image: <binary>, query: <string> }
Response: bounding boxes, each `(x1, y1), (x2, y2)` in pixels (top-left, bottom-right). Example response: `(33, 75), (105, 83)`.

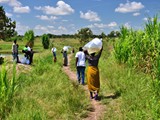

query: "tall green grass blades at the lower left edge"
(0, 64), (16, 119)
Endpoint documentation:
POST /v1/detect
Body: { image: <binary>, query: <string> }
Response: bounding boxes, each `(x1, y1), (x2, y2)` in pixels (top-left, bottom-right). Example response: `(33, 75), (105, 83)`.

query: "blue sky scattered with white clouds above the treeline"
(0, 0), (160, 35)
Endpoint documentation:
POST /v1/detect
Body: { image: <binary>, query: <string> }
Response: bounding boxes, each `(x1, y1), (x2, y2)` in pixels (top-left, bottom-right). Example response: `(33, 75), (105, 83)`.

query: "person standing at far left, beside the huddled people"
(12, 40), (18, 63)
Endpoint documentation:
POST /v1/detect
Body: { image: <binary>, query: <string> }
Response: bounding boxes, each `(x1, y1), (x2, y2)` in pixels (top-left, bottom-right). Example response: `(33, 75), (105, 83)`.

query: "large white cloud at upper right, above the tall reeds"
(115, 1), (144, 13)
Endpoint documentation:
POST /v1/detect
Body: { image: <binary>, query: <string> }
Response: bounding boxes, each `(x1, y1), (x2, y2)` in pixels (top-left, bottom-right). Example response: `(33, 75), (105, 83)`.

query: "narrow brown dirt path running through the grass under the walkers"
(63, 54), (105, 120)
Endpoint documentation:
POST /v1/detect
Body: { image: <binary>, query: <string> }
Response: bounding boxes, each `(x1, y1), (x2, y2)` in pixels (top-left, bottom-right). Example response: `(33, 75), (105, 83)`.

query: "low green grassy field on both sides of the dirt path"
(1, 39), (159, 120)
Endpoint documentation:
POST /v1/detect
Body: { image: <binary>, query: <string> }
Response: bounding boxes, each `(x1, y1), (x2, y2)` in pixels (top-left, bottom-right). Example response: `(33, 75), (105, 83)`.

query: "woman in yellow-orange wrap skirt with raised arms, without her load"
(85, 47), (103, 100)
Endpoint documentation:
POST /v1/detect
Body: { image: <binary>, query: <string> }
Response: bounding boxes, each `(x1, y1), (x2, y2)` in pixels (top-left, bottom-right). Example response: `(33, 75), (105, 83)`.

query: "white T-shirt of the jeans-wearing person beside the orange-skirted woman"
(75, 51), (86, 66)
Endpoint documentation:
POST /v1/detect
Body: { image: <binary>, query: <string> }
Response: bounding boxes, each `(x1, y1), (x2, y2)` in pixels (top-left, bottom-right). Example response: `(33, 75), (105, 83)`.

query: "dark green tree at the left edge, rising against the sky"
(0, 6), (16, 40)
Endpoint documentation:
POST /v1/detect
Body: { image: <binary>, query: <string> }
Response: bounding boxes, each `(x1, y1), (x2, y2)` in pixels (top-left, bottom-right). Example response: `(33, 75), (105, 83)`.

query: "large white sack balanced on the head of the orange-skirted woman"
(83, 38), (102, 54)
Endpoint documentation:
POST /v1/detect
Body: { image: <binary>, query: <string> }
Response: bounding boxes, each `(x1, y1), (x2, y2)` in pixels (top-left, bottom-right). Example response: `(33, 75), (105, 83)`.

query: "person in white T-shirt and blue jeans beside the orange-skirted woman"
(75, 47), (86, 85)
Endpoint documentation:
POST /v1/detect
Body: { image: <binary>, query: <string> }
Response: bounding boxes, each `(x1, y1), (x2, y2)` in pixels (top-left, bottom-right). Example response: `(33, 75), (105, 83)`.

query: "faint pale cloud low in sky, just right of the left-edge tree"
(15, 22), (30, 35)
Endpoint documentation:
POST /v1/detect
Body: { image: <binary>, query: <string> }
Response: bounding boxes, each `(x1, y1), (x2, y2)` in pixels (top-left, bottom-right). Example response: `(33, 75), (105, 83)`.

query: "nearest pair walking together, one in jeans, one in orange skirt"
(75, 47), (103, 100)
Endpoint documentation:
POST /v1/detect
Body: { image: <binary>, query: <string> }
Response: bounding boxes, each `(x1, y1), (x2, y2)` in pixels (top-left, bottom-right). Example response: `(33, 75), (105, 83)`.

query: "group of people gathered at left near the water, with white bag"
(12, 40), (34, 64)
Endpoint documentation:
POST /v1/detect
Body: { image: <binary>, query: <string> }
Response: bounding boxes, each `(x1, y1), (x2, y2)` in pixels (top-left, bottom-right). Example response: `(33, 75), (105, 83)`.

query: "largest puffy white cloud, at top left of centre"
(34, 1), (74, 15)
